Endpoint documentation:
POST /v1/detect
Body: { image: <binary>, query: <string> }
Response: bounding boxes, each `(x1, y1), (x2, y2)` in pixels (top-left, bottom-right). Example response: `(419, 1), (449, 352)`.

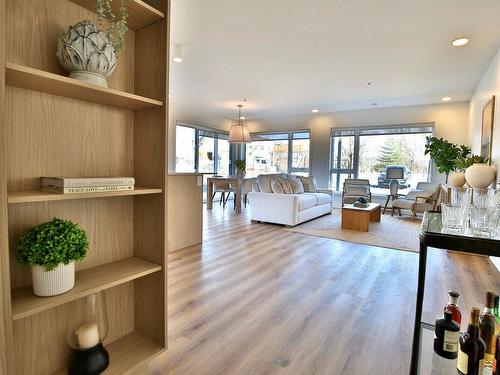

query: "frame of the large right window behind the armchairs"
(328, 122), (436, 191)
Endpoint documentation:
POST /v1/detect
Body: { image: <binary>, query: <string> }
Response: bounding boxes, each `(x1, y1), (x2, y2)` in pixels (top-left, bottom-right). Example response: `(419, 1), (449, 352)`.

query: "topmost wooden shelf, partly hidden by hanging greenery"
(71, 0), (165, 30)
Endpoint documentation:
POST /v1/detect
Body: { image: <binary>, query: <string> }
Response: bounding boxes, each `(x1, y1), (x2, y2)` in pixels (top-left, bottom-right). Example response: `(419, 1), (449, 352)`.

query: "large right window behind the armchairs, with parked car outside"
(330, 124), (434, 194)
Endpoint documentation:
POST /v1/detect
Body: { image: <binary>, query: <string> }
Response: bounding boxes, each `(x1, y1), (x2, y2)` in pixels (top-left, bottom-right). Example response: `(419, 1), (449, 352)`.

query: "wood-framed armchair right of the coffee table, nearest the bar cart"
(391, 182), (441, 220)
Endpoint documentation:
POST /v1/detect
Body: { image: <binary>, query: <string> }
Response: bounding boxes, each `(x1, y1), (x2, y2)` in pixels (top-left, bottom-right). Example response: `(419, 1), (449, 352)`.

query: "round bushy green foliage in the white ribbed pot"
(16, 218), (89, 271)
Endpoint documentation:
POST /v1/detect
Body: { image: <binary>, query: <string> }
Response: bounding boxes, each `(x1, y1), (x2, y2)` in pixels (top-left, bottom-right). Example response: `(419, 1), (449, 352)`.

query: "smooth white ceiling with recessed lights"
(170, 0), (500, 126)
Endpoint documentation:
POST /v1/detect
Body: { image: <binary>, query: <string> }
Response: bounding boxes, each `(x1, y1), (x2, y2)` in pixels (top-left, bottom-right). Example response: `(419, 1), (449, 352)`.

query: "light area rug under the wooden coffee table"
(285, 208), (421, 253)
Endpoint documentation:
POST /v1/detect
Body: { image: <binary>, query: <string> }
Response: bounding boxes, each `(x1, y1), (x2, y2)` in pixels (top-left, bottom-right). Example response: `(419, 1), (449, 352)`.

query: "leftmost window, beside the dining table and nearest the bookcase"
(175, 125), (231, 175)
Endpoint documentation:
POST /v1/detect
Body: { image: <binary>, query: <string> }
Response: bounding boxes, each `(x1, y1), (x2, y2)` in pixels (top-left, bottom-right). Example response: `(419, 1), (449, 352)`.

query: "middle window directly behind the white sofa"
(245, 131), (309, 177)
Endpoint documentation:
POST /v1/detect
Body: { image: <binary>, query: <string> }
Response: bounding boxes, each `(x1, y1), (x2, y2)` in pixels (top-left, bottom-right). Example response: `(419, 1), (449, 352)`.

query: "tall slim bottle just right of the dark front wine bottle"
(479, 292), (496, 375)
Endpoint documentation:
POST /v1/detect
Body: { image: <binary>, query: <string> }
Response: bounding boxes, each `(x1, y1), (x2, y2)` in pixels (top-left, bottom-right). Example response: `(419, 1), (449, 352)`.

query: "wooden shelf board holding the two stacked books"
(7, 187), (163, 204)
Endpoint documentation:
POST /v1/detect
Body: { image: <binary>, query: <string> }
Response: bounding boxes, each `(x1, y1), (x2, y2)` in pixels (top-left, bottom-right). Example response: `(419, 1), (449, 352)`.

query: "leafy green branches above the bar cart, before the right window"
(425, 137), (471, 182)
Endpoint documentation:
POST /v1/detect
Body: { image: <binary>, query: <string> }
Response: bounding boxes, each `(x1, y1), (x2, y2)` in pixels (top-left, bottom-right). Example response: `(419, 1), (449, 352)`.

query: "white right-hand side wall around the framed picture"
(469, 49), (500, 181)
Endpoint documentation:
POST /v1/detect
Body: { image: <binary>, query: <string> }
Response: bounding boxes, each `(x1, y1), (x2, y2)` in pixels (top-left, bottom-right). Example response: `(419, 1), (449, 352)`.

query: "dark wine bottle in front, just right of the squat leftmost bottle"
(457, 307), (486, 375)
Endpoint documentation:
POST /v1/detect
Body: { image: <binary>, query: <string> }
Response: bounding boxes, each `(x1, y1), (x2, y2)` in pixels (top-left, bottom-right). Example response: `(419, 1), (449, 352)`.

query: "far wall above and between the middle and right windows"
(249, 102), (469, 186)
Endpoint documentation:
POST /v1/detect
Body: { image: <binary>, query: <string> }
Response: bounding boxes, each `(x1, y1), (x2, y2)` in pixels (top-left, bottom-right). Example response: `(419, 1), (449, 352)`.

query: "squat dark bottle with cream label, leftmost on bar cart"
(434, 310), (460, 359)
